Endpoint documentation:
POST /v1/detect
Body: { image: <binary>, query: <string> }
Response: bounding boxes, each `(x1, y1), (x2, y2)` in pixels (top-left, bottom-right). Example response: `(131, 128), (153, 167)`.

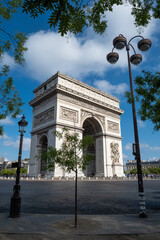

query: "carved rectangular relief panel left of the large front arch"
(60, 106), (78, 122)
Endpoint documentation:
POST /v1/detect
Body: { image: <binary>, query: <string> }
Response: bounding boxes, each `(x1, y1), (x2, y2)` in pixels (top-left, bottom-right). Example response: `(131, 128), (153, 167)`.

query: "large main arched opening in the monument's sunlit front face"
(82, 117), (103, 177)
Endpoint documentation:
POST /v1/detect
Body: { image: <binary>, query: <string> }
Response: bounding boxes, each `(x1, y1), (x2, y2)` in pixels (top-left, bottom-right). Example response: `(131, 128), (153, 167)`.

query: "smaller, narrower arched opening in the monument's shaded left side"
(40, 136), (48, 176)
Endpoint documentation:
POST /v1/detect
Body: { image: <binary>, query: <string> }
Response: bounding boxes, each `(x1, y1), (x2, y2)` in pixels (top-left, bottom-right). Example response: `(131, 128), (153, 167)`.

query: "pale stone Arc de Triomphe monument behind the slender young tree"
(29, 72), (123, 177)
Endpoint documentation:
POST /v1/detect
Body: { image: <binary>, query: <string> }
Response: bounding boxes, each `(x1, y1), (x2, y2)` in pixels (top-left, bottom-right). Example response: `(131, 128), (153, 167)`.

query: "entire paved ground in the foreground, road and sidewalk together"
(0, 180), (160, 240)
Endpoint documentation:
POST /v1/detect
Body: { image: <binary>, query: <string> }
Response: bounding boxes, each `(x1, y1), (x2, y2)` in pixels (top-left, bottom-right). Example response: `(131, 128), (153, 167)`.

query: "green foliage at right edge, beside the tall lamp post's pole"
(134, 71), (160, 131)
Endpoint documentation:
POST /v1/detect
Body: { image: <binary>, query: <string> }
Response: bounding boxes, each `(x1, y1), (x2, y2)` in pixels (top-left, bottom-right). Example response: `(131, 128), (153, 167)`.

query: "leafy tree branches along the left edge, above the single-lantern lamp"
(0, 0), (27, 135)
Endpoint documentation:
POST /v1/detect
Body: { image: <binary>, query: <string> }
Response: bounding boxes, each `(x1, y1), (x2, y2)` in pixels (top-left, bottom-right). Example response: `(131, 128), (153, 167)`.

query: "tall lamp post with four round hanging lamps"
(106, 34), (152, 218)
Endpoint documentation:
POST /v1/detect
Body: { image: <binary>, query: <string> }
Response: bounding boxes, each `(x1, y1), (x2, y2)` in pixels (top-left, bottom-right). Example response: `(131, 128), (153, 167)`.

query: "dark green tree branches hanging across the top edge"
(23, 0), (160, 36)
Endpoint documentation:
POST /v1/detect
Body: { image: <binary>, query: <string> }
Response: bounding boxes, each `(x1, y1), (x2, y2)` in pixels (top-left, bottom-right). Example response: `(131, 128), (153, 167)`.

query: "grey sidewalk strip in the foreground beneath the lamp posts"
(0, 213), (160, 240)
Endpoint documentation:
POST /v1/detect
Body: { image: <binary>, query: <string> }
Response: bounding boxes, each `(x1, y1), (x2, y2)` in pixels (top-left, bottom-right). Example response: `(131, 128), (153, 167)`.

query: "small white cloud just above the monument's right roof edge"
(94, 80), (128, 95)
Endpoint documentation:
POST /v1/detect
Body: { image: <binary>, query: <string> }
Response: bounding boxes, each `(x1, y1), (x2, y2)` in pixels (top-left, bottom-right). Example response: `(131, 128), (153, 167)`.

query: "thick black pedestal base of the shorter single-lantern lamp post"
(9, 197), (21, 218)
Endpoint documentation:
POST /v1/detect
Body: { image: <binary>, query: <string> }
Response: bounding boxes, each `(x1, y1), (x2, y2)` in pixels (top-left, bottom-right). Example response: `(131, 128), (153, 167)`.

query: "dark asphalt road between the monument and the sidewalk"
(0, 180), (160, 215)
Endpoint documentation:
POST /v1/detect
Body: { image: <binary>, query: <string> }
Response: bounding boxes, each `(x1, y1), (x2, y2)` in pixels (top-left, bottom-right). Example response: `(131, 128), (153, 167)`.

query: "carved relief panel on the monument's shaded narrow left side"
(33, 108), (54, 127)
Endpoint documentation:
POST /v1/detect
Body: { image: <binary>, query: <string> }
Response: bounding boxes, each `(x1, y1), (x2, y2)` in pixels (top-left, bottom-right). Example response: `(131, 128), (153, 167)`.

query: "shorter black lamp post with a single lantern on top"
(9, 115), (28, 218)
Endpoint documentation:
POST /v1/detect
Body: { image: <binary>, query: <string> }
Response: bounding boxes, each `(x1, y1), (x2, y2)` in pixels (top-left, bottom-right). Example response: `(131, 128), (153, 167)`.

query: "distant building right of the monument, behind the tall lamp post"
(126, 159), (160, 173)
